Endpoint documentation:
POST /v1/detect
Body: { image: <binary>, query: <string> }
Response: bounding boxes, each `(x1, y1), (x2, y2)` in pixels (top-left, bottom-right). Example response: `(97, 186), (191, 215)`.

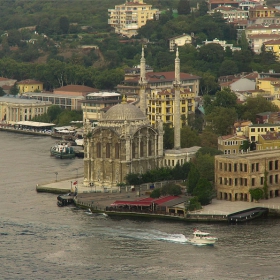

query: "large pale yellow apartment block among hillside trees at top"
(108, 0), (159, 37)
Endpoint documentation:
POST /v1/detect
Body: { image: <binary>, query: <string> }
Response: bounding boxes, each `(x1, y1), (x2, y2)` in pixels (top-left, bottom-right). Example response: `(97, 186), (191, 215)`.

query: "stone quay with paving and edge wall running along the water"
(36, 176), (280, 223)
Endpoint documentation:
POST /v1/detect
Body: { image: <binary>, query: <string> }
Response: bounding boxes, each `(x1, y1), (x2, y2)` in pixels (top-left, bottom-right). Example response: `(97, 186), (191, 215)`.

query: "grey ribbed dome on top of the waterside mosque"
(103, 103), (147, 121)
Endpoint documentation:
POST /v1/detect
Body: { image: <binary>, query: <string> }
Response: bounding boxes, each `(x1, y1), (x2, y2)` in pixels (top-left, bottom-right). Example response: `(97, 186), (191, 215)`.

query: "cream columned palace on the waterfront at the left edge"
(0, 97), (52, 124)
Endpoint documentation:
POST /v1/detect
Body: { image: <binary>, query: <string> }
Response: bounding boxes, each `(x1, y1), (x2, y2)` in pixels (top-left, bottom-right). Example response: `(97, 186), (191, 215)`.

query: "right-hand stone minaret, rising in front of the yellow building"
(173, 48), (181, 149)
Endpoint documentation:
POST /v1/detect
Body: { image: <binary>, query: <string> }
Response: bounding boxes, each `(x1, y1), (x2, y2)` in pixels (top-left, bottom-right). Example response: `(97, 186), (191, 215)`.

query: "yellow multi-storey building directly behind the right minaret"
(147, 88), (195, 126)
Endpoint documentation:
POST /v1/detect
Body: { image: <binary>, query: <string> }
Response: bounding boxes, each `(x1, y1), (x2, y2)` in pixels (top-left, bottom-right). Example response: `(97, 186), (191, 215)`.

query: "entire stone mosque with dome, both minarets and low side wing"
(84, 48), (200, 188)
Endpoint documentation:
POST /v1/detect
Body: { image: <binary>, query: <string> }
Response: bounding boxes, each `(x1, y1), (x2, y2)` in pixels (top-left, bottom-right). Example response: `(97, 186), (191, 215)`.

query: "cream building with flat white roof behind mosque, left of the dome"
(81, 91), (121, 122)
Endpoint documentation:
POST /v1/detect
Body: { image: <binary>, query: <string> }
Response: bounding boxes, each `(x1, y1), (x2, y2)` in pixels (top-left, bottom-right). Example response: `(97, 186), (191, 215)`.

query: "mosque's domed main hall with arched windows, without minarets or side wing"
(84, 98), (163, 189)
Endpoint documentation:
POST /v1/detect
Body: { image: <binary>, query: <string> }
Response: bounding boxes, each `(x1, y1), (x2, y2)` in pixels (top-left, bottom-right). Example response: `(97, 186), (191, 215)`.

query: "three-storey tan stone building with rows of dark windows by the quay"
(215, 149), (280, 202)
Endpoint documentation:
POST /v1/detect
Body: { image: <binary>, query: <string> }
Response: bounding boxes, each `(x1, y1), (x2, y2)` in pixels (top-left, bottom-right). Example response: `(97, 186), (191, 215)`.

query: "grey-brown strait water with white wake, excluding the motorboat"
(0, 132), (280, 279)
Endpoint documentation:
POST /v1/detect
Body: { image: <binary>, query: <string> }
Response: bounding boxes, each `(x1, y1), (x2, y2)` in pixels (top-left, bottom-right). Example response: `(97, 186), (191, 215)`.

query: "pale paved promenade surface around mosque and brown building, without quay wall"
(36, 177), (280, 215)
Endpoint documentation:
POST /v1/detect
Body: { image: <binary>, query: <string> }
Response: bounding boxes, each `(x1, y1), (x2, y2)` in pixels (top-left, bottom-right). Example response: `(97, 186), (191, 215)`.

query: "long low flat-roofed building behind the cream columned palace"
(24, 92), (84, 111)
